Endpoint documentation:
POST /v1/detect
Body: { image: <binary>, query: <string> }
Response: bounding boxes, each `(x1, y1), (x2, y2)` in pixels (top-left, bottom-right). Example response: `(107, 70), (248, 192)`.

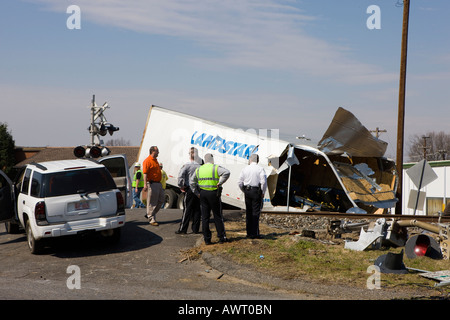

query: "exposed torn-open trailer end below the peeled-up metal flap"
(269, 145), (397, 213)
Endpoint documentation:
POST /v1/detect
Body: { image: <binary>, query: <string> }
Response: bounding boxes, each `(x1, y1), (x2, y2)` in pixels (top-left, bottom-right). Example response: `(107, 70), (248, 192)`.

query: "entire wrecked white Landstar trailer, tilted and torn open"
(138, 106), (397, 213)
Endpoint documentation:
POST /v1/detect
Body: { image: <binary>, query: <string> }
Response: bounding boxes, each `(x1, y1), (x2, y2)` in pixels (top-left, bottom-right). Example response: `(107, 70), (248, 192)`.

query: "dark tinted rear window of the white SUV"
(40, 168), (116, 198)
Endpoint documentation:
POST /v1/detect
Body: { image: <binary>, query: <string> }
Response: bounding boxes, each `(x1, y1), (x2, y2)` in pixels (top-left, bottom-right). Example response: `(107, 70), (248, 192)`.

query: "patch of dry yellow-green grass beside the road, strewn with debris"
(187, 221), (450, 293)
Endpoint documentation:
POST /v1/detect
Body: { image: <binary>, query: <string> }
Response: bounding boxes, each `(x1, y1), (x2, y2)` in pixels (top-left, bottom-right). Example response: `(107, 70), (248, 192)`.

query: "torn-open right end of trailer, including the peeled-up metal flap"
(272, 108), (397, 213)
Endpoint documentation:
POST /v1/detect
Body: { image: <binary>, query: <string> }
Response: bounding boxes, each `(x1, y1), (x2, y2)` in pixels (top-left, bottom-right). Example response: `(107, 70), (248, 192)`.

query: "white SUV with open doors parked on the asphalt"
(0, 157), (133, 253)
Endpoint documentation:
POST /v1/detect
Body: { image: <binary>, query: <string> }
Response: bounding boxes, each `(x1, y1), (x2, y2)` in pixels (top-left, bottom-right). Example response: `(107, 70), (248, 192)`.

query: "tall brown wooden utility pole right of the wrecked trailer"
(395, 0), (409, 215)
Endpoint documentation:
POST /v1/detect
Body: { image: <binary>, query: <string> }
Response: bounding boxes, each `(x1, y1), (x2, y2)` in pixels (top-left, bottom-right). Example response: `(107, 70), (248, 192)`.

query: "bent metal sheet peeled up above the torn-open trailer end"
(318, 108), (387, 157)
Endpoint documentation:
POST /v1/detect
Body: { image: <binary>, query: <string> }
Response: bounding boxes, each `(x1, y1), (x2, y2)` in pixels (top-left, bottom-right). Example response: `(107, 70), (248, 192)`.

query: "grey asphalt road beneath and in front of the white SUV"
(0, 209), (310, 301)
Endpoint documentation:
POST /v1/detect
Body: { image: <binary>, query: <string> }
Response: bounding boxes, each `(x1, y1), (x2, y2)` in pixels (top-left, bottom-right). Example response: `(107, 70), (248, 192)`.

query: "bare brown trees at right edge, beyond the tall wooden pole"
(408, 131), (450, 161)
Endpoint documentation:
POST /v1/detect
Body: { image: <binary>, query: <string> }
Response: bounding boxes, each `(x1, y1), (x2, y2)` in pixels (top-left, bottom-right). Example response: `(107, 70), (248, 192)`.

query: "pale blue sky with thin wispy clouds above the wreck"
(0, 0), (450, 158)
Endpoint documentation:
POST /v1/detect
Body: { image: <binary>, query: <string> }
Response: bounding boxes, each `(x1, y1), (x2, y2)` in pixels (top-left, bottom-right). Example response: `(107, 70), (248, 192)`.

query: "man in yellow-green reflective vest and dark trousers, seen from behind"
(190, 153), (230, 244)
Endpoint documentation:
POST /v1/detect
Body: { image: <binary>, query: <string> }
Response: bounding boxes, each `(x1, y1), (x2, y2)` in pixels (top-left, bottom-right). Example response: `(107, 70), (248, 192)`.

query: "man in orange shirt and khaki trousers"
(142, 146), (164, 226)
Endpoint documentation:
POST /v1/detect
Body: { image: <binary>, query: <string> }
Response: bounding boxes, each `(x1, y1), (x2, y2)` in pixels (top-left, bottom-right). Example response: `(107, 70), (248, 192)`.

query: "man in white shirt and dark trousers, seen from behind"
(238, 154), (267, 239)
